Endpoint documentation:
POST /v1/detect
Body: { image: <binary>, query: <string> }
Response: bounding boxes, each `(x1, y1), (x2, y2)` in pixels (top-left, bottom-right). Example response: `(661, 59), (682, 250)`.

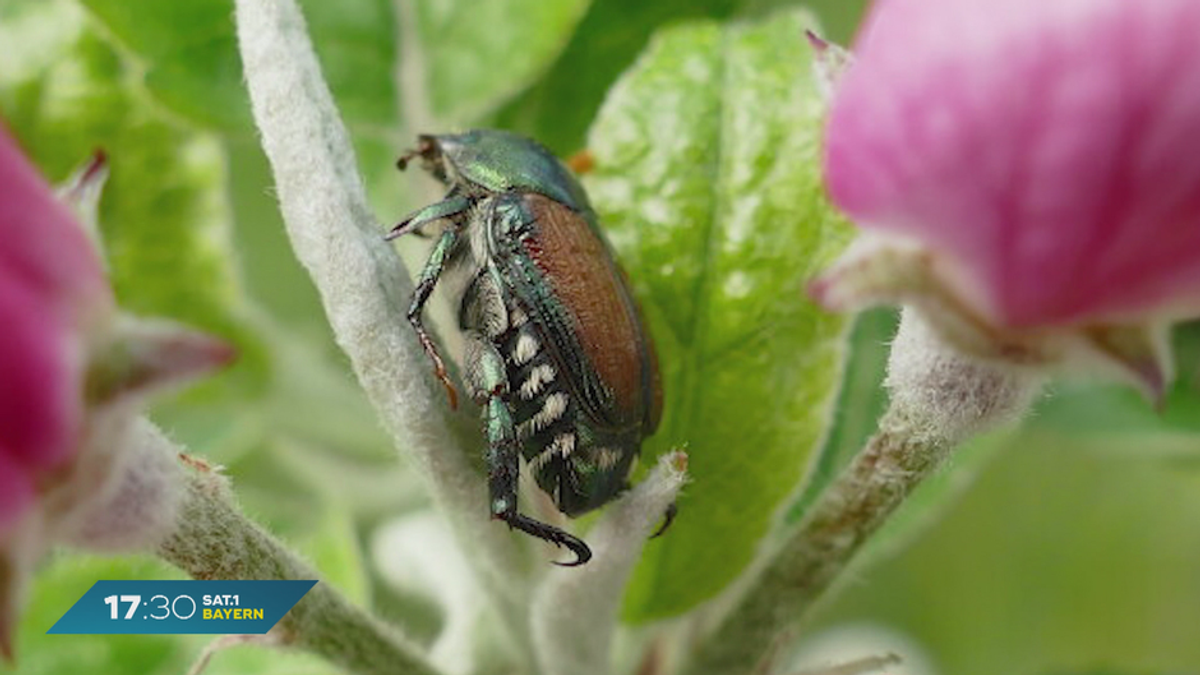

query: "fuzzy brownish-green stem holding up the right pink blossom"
(688, 311), (1040, 675)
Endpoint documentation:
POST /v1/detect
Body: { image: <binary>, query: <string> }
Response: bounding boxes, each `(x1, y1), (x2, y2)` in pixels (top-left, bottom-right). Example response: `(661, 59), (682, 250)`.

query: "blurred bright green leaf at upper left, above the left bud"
(0, 2), (269, 400)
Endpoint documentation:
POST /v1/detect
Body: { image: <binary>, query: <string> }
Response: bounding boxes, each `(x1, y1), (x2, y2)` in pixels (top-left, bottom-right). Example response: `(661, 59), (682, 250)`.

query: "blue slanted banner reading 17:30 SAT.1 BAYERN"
(47, 580), (317, 635)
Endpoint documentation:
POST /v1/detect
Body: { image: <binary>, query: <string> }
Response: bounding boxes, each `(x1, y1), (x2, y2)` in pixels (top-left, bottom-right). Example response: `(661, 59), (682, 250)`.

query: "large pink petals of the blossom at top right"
(826, 0), (1200, 329)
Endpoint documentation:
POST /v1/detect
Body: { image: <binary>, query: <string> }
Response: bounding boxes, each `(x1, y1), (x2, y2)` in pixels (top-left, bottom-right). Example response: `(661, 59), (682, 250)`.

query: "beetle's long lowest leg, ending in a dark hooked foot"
(470, 335), (592, 567)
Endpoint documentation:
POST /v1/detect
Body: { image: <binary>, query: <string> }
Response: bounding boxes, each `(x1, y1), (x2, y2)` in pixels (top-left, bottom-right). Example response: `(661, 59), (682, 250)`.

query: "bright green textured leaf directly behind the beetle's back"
(584, 7), (848, 620)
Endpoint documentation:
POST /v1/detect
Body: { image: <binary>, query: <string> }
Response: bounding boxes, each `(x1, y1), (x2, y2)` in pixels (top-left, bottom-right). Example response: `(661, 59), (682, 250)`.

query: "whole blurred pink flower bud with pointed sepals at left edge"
(0, 126), (233, 658)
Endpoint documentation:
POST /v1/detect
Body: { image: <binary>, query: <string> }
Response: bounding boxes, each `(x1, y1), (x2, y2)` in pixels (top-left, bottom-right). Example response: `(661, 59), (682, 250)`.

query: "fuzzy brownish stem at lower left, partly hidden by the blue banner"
(158, 458), (437, 675)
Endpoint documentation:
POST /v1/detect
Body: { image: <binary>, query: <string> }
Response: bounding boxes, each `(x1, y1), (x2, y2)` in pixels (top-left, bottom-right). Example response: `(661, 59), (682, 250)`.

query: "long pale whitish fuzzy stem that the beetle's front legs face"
(235, 0), (529, 638)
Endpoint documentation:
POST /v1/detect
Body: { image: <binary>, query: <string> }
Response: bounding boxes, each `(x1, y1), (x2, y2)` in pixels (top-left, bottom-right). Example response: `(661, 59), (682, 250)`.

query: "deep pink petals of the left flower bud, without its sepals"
(0, 127), (114, 533)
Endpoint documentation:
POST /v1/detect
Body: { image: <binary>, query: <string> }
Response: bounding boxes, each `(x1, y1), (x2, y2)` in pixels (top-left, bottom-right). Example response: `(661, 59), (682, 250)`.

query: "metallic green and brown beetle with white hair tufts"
(386, 130), (673, 567)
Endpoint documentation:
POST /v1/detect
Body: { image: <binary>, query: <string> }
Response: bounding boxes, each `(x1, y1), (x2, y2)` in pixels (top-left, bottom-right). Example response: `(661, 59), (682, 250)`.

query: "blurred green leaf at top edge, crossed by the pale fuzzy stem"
(82, 0), (590, 141)
